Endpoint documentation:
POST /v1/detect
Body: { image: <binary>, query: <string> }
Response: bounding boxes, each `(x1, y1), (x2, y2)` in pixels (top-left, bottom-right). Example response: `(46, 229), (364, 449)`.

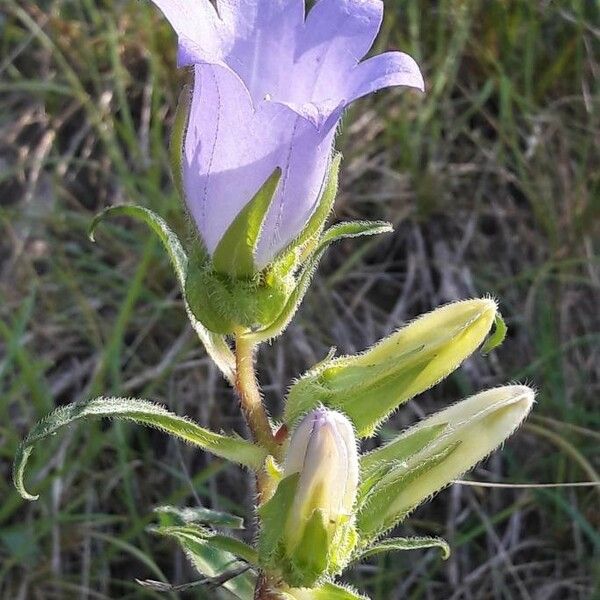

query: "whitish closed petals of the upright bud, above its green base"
(284, 408), (358, 552)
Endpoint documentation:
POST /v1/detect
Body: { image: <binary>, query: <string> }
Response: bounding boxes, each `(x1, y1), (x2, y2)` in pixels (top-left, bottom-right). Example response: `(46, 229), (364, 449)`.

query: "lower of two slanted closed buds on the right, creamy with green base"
(357, 385), (534, 541)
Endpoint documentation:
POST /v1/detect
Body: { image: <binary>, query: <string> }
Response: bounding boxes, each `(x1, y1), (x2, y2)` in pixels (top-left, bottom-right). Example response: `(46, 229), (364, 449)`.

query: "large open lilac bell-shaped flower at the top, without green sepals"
(153, 0), (423, 269)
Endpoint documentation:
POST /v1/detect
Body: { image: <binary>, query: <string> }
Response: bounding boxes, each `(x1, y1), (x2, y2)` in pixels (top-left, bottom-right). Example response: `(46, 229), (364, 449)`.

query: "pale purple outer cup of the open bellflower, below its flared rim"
(183, 63), (335, 267)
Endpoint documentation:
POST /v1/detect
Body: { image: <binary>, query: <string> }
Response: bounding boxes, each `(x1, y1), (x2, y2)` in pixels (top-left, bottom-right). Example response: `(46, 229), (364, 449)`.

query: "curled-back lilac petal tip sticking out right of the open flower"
(345, 52), (425, 103)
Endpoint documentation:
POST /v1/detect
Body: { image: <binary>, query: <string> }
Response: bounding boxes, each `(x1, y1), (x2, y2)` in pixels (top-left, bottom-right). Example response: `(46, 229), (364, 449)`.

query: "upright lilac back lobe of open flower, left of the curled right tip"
(294, 0), (383, 102)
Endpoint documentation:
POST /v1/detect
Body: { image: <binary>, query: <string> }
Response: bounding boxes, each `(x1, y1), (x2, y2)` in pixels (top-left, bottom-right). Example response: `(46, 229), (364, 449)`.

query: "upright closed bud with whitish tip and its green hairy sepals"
(259, 408), (359, 587)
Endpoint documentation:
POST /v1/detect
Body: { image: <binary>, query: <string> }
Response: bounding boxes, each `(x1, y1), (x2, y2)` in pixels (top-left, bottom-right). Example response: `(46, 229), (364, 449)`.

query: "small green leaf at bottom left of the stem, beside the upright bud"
(152, 527), (256, 600)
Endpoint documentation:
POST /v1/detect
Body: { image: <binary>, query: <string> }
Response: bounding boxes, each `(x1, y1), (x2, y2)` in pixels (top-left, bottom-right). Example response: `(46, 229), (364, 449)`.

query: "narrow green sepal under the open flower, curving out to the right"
(244, 221), (392, 343)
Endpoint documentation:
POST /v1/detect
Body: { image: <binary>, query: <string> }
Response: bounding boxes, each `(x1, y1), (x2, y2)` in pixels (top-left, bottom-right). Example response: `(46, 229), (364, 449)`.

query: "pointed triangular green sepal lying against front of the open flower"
(212, 167), (281, 279)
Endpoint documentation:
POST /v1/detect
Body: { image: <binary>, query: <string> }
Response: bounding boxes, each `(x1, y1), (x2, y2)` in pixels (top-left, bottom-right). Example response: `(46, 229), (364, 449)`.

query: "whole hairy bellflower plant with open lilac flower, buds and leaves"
(13, 0), (534, 600)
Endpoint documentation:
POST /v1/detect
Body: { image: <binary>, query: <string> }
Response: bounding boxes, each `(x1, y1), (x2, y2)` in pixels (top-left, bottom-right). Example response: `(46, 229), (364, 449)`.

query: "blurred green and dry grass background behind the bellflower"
(0, 0), (600, 600)
